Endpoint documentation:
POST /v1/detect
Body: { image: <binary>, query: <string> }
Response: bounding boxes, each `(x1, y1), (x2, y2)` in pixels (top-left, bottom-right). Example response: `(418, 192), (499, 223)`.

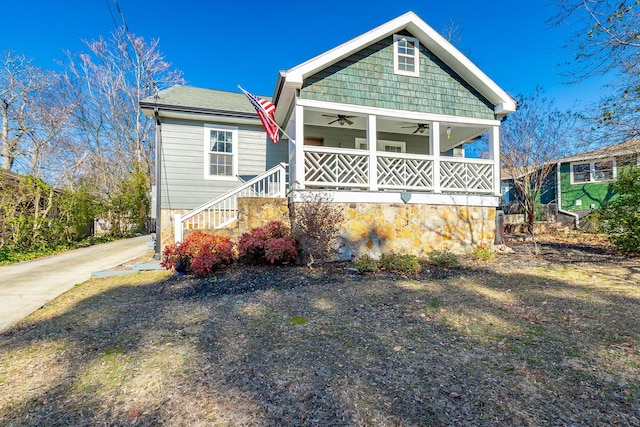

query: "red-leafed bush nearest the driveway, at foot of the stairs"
(161, 230), (236, 277)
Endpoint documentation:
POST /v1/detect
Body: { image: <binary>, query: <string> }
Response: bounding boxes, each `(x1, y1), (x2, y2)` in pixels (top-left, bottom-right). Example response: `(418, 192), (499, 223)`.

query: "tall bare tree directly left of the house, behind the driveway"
(65, 28), (183, 234)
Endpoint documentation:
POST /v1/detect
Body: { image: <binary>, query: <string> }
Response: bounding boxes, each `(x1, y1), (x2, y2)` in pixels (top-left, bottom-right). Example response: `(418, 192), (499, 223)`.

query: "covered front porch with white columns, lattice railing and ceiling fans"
(287, 98), (500, 204)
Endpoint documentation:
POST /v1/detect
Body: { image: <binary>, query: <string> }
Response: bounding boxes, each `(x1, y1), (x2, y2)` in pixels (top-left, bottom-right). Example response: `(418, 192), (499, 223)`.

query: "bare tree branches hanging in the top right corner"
(552, 0), (640, 142)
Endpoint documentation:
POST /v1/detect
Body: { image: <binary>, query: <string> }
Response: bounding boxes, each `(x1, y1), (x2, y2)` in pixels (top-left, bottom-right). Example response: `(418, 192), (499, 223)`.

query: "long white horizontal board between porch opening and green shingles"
(297, 98), (500, 126)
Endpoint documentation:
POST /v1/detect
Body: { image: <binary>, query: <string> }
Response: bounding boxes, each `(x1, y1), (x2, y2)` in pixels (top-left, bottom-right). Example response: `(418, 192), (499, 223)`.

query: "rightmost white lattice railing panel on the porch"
(440, 158), (493, 193)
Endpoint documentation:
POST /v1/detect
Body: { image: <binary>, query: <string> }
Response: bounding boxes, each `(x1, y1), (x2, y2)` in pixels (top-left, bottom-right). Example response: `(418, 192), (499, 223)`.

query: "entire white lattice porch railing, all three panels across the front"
(304, 147), (494, 194)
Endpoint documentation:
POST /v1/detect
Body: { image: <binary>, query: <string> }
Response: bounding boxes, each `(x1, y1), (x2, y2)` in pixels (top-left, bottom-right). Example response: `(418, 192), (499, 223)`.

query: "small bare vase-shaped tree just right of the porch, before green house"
(500, 87), (575, 236)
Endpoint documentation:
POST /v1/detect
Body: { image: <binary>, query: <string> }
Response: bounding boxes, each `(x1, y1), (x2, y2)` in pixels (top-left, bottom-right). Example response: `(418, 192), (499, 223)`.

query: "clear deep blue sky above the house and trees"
(0, 0), (602, 110)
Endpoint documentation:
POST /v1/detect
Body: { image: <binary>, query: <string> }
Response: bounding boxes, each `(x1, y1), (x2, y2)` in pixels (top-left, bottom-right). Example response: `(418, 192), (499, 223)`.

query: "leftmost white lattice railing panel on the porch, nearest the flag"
(304, 147), (369, 188)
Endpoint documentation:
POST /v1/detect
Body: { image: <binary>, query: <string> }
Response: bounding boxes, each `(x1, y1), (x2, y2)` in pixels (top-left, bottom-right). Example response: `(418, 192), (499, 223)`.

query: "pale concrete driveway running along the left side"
(0, 236), (149, 333)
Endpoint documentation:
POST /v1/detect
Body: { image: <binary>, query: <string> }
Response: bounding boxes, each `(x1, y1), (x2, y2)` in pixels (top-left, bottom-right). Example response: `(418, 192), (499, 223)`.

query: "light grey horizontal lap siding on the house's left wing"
(161, 119), (287, 209)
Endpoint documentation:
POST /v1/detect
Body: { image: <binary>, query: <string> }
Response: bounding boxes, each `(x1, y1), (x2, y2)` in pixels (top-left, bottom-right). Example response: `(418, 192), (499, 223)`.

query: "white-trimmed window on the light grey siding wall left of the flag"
(204, 125), (238, 179)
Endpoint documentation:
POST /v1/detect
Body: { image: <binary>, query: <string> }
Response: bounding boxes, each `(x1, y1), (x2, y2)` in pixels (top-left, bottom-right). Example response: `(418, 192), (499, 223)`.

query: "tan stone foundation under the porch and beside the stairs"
(162, 198), (496, 259)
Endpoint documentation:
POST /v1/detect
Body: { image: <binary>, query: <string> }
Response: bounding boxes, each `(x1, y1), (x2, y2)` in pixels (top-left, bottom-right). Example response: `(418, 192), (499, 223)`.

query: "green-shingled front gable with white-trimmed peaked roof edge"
(273, 12), (517, 123)
